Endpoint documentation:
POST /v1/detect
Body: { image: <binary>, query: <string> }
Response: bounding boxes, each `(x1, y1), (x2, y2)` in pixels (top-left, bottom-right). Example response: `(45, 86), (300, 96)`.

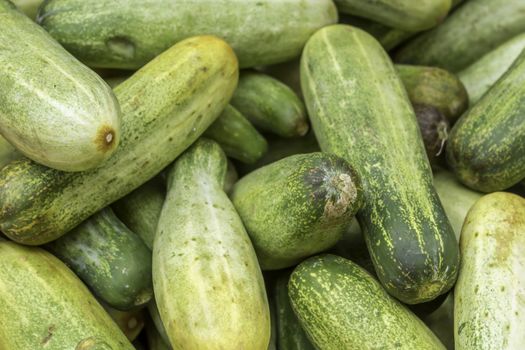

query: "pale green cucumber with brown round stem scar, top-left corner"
(0, 0), (121, 171)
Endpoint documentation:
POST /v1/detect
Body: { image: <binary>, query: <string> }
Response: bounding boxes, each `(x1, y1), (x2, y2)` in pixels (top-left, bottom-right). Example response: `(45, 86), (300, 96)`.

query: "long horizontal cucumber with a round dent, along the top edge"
(38, 0), (337, 69)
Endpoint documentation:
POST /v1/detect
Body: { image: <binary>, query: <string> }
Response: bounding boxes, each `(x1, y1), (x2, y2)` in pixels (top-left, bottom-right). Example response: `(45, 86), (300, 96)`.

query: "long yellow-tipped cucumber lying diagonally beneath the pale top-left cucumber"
(0, 36), (238, 245)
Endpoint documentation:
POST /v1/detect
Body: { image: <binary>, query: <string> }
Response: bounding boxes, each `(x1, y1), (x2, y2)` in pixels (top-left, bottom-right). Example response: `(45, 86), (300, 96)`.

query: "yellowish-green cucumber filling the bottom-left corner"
(0, 241), (134, 350)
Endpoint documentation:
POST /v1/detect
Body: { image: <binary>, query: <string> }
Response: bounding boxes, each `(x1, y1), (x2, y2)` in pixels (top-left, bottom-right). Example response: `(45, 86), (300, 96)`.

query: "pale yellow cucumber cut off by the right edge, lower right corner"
(454, 192), (525, 350)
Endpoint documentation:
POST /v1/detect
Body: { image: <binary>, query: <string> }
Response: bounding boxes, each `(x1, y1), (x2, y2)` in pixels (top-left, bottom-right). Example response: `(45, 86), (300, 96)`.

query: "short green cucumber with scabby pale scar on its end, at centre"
(230, 152), (362, 270)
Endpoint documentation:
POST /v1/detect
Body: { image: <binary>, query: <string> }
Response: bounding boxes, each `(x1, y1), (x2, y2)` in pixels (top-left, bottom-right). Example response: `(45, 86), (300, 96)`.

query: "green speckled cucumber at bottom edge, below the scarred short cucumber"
(288, 254), (444, 350)
